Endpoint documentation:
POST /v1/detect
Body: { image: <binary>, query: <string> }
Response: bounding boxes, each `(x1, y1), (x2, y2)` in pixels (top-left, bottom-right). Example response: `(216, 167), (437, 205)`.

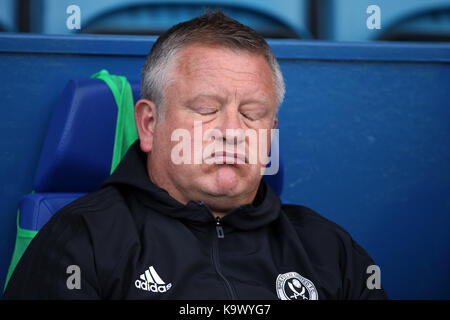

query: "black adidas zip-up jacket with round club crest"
(4, 142), (386, 300)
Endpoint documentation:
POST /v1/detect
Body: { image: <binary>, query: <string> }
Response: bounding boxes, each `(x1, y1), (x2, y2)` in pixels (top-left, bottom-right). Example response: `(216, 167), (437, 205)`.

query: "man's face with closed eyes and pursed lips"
(148, 45), (276, 212)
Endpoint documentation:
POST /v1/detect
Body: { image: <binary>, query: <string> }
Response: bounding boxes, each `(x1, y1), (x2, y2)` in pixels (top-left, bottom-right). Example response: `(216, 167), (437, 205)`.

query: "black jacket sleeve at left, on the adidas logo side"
(3, 212), (100, 300)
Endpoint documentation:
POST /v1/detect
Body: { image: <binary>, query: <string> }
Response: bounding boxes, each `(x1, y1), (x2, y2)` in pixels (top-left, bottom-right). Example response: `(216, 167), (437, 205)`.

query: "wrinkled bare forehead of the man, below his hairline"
(173, 44), (275, 100)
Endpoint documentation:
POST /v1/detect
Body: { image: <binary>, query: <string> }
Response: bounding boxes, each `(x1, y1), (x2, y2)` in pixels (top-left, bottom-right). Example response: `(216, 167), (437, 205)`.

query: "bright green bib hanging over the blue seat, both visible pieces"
(3, 70), (138, 290)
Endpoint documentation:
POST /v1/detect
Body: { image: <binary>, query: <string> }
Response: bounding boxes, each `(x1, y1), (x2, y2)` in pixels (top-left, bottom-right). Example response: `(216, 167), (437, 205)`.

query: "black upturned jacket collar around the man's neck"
(101, 140), (281, 230)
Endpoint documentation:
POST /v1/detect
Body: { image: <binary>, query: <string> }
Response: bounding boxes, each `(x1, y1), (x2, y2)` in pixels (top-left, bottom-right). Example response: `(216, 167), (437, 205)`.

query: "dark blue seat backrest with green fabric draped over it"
(34, 79), (139, 192)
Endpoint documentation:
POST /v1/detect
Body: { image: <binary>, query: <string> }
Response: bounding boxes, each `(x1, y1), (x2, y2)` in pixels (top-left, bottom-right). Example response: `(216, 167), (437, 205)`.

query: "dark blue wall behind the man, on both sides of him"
(0, 34), (450, 299)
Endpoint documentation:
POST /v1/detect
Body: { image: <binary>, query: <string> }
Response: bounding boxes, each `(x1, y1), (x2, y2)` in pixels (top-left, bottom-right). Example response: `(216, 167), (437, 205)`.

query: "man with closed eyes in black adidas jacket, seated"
(4, 12), (386, 300)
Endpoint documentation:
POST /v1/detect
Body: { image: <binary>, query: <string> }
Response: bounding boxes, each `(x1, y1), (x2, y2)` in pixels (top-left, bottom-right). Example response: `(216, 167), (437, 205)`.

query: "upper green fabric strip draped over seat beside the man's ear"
(91, 69), (138, 173)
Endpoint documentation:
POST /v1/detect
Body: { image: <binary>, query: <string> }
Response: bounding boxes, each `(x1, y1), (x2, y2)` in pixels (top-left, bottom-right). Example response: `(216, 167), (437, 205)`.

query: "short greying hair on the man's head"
(141, 11), (285, 119)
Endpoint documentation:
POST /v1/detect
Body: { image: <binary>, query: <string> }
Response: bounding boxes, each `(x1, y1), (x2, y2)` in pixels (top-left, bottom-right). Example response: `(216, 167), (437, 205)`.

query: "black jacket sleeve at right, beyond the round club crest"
(344, 237), (388, 300)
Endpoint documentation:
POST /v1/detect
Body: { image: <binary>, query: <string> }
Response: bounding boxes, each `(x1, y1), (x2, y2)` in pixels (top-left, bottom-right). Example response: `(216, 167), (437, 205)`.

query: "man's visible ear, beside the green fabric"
(134, 99), (158, 153)
